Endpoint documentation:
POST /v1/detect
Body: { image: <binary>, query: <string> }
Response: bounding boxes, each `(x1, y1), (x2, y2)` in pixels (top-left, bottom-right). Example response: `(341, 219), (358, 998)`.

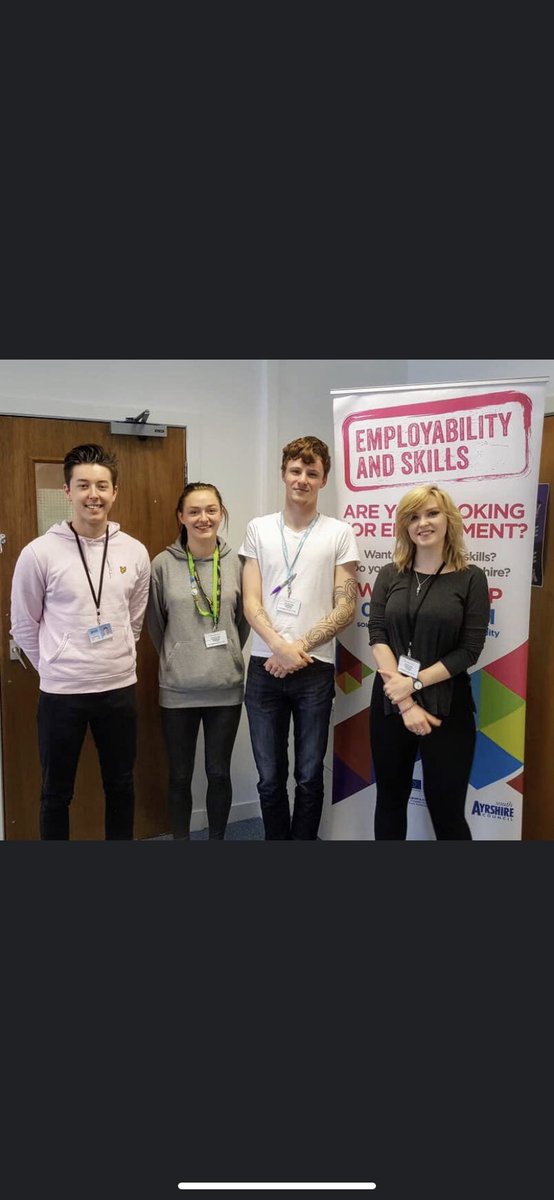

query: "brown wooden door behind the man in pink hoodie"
(0, 416), (186, 840)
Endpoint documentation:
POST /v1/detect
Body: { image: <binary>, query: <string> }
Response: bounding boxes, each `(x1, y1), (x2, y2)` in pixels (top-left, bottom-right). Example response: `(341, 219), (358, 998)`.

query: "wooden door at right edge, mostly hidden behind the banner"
(522, 415), (554, 841)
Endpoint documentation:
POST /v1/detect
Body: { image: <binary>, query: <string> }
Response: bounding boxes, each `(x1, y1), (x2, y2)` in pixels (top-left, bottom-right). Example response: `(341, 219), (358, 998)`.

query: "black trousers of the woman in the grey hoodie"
(159, 704), (242, 841)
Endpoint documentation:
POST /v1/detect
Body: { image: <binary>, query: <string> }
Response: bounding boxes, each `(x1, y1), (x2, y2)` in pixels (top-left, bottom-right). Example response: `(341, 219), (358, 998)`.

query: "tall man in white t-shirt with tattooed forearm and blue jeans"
(239, 437), (360, 840)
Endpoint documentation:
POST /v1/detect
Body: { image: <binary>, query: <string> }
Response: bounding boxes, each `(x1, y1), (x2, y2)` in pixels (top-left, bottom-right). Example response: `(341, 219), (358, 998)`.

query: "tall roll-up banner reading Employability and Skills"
(325, 379), (548, 841)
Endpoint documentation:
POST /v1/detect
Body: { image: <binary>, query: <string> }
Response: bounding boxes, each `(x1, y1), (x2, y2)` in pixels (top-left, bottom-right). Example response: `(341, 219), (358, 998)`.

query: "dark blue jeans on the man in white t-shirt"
(245, 655), (335, 841)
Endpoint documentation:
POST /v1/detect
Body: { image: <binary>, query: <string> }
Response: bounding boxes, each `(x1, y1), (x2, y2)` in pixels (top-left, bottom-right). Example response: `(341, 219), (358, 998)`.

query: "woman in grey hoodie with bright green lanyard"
(146, 482), (249, 840)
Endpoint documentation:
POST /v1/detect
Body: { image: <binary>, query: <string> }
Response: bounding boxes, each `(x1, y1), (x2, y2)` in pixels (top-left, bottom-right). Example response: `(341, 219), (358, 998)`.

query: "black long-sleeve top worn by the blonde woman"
(369, 563), (490, 716)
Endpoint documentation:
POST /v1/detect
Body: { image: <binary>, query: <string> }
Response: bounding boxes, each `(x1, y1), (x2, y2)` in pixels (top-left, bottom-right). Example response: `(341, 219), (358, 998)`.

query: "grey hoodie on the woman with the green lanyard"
(146, 538), (249, 708)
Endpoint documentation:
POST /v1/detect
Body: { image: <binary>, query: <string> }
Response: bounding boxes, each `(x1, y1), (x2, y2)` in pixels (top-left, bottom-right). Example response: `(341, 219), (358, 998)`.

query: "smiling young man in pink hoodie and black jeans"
(11, 444), (150, 839)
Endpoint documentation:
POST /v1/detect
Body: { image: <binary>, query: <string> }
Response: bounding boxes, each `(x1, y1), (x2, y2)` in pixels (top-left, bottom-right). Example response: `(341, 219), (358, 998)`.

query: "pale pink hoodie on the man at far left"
(11, 521), (150, 694)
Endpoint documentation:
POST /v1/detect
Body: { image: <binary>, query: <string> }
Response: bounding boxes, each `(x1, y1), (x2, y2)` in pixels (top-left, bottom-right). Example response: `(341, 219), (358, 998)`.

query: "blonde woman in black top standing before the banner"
(369, 484), (490, 840)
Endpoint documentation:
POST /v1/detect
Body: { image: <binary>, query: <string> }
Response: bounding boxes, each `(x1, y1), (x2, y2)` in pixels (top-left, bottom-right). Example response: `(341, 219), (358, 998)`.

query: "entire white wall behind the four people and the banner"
(0, 359), (554, 833)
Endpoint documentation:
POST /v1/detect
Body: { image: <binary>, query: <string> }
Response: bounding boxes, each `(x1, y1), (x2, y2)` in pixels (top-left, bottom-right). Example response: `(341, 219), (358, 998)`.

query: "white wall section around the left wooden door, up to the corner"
(0, 359), (267, 828)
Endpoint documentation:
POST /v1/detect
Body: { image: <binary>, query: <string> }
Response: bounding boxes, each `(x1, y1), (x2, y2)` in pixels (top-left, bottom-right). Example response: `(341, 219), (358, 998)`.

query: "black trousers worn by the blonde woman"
(369, 674), (476, 841)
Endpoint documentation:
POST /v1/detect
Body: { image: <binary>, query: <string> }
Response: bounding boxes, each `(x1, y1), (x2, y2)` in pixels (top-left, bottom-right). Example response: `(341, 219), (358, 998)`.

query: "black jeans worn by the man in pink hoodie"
(37, 684), (137, 841)
